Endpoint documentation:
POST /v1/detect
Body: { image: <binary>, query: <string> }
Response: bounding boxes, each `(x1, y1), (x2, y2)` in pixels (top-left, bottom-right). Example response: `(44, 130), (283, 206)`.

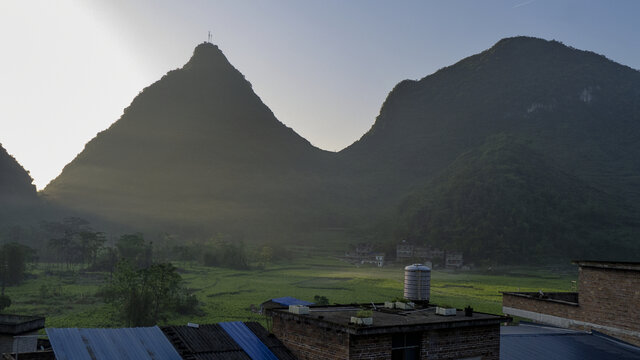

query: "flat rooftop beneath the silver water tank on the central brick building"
(270, 304), (511, 335)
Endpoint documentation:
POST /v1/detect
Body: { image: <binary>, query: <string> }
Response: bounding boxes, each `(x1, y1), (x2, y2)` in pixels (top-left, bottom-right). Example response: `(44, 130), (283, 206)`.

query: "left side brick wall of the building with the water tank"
(271, 316), (349, 360)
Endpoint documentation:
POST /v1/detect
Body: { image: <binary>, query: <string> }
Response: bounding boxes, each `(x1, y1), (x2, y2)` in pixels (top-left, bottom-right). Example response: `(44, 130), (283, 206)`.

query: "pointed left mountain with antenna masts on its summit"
(44, 43), (334, 236)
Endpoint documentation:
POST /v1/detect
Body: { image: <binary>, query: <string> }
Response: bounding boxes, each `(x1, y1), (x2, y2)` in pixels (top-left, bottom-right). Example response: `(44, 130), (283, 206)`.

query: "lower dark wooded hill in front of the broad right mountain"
(400, 134), (640, 263)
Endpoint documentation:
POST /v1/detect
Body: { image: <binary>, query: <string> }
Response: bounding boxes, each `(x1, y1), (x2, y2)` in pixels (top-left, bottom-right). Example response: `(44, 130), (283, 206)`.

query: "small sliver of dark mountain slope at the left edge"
(0, 145), (38, 224)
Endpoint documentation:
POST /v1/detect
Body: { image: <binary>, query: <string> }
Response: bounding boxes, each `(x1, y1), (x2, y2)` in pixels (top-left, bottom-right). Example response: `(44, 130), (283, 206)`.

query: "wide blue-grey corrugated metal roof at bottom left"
(46, 326), (182, 360)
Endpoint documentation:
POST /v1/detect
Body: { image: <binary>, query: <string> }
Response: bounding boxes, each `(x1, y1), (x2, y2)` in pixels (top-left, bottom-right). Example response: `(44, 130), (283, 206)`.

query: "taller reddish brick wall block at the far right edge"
(579, 267), (640, 331)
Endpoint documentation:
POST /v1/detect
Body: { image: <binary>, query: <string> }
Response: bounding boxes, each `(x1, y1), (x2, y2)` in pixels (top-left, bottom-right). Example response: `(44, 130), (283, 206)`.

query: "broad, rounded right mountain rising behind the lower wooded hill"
(339, 37), (640, 208)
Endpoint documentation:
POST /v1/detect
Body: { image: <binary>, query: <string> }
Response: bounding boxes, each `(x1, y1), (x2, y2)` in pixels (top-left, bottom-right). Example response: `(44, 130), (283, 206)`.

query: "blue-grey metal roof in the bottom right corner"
(500, 325), (640, 360)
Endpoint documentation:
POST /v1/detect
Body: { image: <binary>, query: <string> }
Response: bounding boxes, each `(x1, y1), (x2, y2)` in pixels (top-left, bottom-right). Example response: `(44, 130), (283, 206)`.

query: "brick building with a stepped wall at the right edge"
(502, 261), (640, 345)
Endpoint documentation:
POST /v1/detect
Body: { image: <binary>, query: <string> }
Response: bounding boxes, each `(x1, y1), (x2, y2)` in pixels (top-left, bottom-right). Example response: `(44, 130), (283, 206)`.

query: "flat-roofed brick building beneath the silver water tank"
(269, 304), (508, 360)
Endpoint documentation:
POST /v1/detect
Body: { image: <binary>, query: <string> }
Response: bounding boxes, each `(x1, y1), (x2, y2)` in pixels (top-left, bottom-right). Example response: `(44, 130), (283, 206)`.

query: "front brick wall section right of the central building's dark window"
(420, 324), (500, 360)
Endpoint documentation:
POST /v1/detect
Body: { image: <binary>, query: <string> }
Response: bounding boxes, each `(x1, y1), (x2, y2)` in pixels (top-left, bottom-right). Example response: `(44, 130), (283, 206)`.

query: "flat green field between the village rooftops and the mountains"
(5, 256), (576, 327)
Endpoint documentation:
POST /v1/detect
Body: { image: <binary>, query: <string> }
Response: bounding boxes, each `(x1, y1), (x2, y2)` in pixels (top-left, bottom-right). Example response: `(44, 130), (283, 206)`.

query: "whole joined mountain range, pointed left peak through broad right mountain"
(44, 37), (640, 262)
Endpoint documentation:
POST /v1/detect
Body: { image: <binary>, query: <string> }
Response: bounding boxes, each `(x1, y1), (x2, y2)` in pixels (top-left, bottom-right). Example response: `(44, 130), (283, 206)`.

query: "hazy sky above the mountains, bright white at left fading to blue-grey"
(0, 0), (640, 189)
